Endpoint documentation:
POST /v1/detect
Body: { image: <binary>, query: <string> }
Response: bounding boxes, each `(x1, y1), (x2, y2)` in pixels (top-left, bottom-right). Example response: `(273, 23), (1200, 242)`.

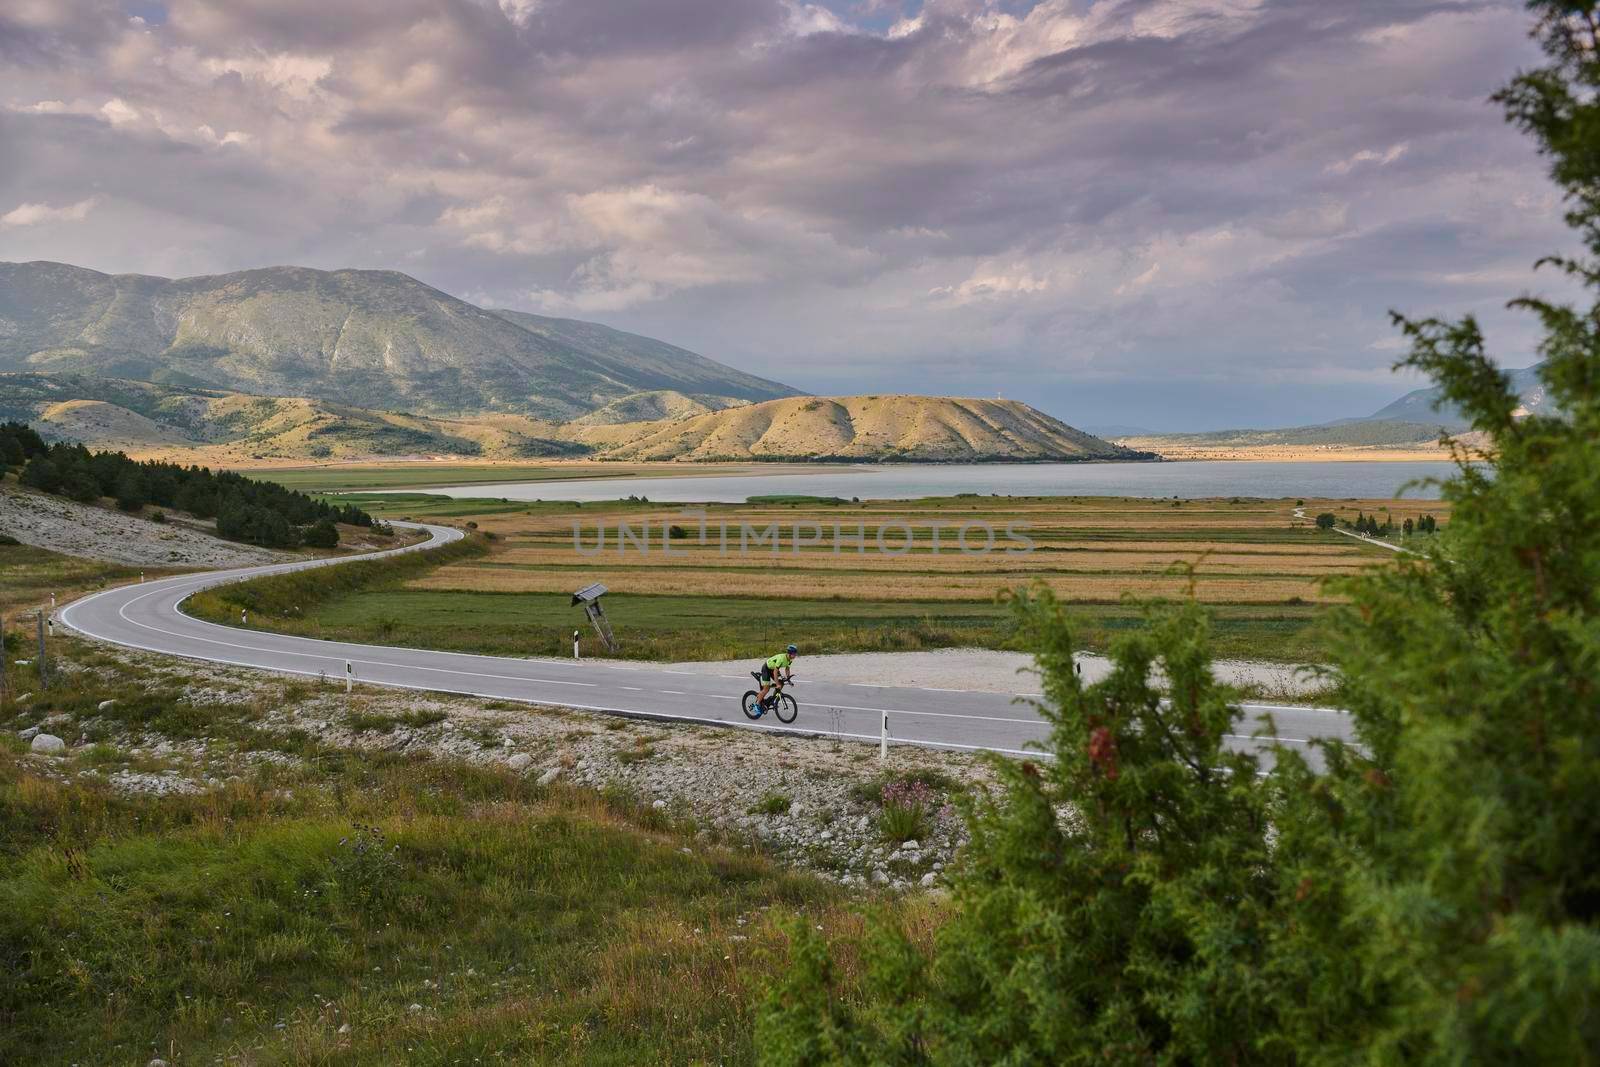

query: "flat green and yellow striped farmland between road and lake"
(195, 494), (1448, 661)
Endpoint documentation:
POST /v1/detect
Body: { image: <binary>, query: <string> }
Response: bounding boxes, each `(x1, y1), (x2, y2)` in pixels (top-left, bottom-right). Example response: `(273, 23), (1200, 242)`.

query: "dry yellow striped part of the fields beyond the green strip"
(410, 498), (1443, 603)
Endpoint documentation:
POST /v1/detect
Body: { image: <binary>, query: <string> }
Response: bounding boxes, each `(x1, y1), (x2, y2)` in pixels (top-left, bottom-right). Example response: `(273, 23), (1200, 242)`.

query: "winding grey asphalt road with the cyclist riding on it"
(58, 523), (1352, 761)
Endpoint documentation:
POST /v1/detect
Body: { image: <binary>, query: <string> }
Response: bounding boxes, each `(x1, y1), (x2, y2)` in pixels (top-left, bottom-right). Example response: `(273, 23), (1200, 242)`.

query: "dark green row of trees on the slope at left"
(0, 422), (376, 549)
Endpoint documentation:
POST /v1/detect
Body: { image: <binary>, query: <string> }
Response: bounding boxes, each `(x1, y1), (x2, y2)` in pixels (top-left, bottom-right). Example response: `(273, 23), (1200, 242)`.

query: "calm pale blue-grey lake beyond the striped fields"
(394, 461), (1453, 504)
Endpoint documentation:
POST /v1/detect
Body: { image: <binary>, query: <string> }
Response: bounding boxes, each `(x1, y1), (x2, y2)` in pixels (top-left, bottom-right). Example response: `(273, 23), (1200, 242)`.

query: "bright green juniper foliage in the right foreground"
(760, 2), (1600, 1064)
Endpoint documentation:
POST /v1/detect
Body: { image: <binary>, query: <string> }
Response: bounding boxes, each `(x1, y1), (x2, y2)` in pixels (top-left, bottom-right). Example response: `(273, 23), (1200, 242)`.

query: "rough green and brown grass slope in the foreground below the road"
(0, 641), (936, 1065)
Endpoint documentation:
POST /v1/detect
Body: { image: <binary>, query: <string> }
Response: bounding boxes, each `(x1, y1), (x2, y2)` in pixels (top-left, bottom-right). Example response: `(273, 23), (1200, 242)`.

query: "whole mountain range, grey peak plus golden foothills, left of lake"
(0, 262), (1149, 466)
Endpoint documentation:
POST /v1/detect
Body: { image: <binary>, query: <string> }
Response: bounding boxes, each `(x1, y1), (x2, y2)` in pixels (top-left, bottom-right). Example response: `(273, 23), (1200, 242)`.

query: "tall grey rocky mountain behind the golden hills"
(0, 262), (797, 421)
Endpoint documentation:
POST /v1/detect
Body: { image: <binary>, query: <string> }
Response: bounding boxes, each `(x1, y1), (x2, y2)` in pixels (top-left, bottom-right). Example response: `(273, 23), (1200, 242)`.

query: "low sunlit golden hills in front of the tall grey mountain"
(0, 374), (1149, 466)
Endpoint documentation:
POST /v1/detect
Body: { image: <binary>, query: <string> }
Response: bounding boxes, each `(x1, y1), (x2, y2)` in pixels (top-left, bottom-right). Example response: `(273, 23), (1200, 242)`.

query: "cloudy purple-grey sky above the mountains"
(0, 0), (1568, 429)
